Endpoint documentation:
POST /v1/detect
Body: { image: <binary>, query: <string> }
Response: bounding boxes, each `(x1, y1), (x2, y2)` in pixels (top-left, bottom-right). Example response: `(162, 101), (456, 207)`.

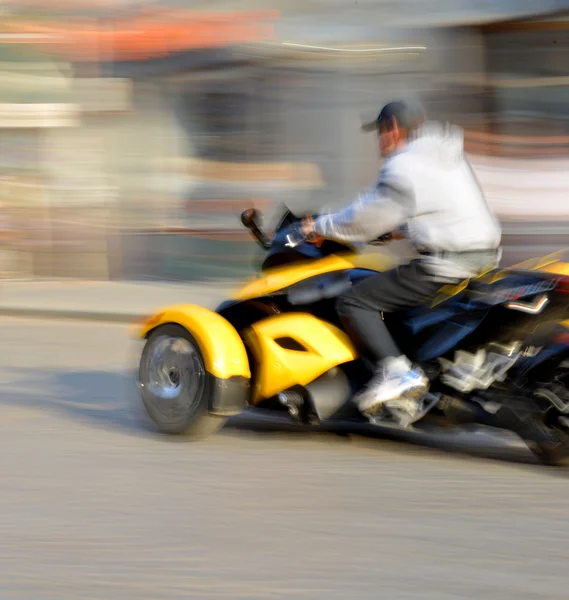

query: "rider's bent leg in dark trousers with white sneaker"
(338, 261), (440, 424)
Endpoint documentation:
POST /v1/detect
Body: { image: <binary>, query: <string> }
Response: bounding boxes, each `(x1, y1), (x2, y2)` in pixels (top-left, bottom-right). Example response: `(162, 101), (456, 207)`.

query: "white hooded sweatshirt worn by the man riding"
(315, 122), (501, 280)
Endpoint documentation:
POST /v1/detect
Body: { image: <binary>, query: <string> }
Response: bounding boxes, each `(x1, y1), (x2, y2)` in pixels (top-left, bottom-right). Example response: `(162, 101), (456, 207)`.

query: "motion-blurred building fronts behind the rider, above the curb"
(0, 0), (569, 281)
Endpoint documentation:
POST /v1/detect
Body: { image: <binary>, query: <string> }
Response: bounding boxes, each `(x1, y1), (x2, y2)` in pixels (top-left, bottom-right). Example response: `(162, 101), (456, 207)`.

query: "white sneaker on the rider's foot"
(354, 356), (429, 424)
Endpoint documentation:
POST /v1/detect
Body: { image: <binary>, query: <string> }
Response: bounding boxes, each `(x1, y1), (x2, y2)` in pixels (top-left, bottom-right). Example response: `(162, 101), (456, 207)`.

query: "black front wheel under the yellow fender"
(138, 324), (227, 439)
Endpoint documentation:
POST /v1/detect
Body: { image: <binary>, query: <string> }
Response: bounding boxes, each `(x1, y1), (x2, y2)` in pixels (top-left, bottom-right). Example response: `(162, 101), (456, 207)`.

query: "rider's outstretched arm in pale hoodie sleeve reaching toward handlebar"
(314, 164), (415, 243)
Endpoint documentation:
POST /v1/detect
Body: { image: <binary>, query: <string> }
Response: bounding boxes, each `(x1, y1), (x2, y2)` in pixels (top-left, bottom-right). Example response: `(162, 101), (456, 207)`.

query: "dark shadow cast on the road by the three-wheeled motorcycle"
(0, 368), (560, 472)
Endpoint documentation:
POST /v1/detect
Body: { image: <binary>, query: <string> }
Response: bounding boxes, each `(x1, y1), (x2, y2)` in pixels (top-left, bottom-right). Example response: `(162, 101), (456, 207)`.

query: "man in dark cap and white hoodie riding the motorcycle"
(302, 101), (501, 425)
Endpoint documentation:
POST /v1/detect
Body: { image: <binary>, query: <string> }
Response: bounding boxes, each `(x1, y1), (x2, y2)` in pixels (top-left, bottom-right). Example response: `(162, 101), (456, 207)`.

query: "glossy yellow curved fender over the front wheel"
(139, 304), (251, 379)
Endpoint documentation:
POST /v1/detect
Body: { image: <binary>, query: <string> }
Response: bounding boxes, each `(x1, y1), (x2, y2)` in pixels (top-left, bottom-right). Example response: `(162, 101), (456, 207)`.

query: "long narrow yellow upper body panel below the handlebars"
(232, 253), (397, 300)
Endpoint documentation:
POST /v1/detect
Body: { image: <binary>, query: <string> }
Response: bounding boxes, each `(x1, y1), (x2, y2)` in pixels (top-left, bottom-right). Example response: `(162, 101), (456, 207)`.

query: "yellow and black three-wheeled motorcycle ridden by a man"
(134, 209), (569, 463)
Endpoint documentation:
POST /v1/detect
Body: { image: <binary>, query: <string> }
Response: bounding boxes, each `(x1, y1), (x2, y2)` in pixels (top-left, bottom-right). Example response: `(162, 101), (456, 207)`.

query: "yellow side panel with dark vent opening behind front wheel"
(245, 313), (357, 404)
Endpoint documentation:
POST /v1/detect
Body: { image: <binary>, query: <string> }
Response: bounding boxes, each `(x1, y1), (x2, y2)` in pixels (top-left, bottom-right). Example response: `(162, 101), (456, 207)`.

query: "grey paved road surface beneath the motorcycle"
(0, 320), (569, 600)
